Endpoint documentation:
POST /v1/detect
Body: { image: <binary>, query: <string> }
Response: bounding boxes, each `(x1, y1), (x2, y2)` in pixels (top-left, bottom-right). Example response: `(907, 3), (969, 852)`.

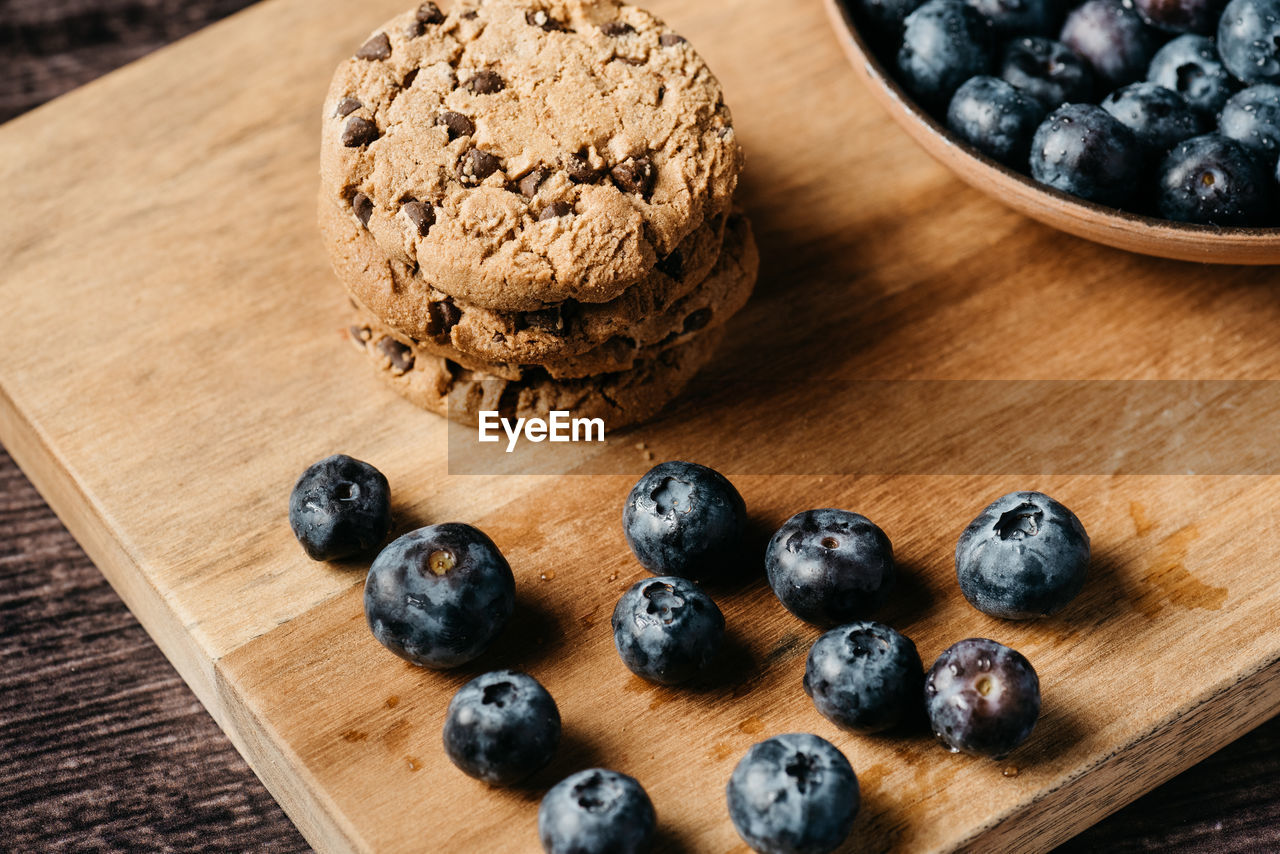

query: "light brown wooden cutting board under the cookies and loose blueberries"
(0, 0), (1280, 851)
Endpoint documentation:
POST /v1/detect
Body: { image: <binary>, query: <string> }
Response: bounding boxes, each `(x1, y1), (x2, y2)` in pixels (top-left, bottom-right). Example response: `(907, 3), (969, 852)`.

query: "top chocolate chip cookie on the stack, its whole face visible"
(321, 0), (742, 311)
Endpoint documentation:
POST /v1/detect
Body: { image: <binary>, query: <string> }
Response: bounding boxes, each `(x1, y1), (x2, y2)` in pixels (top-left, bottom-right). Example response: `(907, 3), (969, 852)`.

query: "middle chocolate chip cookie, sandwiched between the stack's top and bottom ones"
(320, 200), (759, 379)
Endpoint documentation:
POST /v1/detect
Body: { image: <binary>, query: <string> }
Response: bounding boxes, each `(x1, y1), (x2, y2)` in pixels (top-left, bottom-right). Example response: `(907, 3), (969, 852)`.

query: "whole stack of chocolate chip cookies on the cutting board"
(320, 0), (758, 428)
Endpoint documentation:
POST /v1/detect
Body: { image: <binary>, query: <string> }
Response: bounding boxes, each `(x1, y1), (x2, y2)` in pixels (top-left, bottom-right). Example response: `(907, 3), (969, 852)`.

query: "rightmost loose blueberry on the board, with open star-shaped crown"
(956, 492), (1089, 620)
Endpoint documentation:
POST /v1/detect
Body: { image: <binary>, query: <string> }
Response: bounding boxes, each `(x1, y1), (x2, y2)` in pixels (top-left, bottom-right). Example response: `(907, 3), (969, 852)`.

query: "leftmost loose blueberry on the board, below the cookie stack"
(289, 453), (392, 561)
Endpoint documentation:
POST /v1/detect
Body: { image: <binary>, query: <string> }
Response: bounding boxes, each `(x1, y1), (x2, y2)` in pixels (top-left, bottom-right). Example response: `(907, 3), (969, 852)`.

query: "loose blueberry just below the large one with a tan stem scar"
(444, 670), (561, 786)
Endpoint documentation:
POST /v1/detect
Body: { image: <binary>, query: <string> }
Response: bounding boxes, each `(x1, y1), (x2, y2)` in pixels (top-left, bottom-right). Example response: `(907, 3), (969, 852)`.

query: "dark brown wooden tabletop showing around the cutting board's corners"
(0, 0), (1280, 854)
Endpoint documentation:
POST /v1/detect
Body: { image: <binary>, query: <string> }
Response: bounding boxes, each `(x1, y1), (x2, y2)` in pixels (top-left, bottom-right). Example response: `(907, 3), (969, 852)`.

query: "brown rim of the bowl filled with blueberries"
(824, 0), (1280, 253)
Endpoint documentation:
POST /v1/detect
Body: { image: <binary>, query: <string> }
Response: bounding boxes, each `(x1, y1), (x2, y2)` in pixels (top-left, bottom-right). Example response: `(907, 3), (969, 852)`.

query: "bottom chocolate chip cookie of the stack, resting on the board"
(348, 307), (723, 430)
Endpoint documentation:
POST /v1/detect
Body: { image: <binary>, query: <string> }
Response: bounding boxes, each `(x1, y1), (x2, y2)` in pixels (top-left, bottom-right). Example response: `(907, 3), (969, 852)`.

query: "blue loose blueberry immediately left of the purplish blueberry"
(804, 621), (924, 734)
